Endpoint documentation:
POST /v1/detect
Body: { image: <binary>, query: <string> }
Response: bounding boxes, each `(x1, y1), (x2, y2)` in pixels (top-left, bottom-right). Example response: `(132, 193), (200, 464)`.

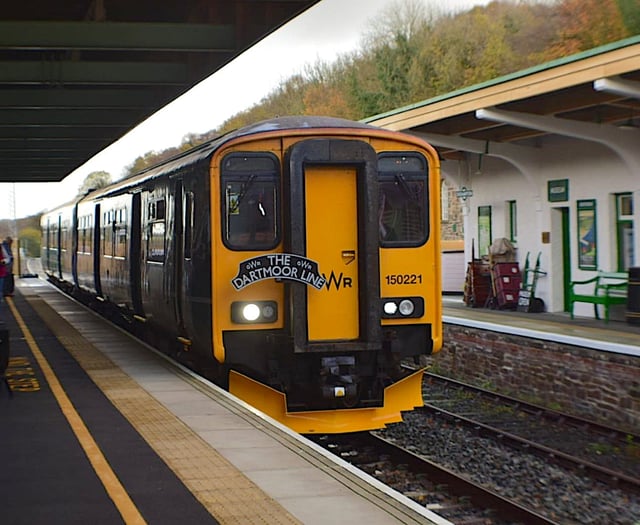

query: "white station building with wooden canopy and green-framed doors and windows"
(368, 37), (640, 319)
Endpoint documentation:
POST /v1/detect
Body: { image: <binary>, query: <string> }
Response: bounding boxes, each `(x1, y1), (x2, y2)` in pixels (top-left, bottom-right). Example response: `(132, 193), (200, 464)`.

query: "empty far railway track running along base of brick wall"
(420, 374), (640, 493)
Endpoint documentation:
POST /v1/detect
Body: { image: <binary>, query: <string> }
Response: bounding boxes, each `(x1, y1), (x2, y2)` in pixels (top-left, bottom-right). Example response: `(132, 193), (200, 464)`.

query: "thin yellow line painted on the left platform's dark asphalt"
(6, 297), (146, 524)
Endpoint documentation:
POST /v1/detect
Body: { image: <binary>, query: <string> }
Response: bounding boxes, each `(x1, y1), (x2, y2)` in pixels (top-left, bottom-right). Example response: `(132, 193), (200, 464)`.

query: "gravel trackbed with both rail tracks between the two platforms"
(312, 374), (640, 525)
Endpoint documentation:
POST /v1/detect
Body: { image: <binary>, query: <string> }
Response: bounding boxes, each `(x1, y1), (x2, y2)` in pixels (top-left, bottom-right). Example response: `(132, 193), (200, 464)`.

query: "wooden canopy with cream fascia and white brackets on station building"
(367, 36), (640, 163)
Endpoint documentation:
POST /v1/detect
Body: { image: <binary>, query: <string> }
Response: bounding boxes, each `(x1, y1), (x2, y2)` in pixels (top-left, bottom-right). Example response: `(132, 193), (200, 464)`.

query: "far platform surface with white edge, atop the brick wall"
(442, 296), (640, 357)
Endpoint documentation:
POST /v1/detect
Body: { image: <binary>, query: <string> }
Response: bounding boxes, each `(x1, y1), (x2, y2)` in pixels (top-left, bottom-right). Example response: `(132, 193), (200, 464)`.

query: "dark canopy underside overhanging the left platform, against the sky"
(0, 0), (318, 182)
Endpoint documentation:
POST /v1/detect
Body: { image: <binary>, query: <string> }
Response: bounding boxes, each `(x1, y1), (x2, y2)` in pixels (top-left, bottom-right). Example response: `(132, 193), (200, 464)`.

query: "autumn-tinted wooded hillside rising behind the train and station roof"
(101, 0), (640, 167)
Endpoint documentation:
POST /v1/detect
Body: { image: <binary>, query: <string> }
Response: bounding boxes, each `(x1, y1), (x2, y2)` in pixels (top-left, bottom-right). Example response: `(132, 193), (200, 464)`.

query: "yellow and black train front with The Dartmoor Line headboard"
(210, 119), (442, 433)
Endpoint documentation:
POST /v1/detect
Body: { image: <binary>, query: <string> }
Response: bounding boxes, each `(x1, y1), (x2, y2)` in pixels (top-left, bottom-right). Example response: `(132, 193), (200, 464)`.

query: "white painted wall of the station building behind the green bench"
(458, 131), (640, 316)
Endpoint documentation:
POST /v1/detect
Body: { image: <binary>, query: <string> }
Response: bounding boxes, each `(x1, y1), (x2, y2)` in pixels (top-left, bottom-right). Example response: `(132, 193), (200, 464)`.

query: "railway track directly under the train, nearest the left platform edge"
(312, 432), (556, 525)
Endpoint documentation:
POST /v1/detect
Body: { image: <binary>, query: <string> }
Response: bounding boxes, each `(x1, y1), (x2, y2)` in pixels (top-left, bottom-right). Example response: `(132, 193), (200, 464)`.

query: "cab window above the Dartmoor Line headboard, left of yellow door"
(221, 153), (280, 250)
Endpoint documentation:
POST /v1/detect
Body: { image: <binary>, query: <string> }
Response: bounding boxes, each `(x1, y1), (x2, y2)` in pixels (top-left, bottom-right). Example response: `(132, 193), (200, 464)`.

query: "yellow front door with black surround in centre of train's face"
(285, 139), (380, 352)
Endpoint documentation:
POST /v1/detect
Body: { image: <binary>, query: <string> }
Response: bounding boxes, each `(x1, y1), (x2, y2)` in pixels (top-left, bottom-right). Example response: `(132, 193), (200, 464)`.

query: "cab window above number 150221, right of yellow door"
(378, 152), (429, 247)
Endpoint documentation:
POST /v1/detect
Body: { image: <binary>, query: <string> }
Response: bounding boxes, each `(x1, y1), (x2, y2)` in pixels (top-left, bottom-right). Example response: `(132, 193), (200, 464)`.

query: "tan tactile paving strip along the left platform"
(28, 297), (300, 524)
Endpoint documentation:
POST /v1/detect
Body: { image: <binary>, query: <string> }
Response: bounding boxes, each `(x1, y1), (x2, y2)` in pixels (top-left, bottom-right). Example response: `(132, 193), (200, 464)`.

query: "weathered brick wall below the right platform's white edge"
(430, 324), (640, 433)
